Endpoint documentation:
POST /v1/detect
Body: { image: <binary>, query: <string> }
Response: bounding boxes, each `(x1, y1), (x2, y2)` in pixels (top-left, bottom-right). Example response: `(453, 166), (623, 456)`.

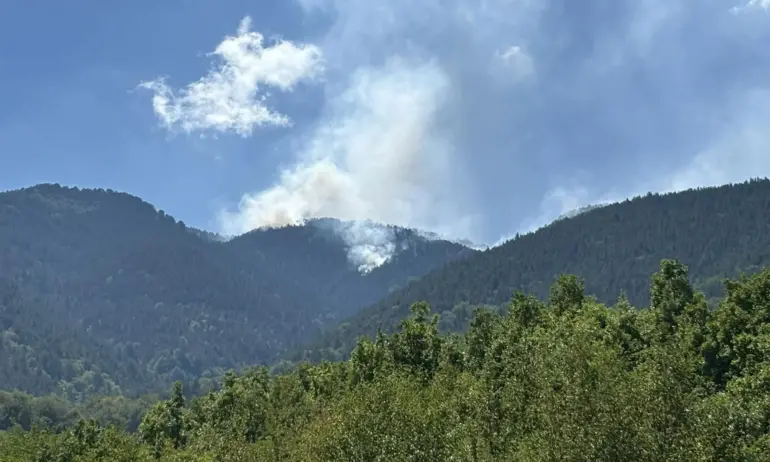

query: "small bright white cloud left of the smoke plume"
(140, 17), (322, 136)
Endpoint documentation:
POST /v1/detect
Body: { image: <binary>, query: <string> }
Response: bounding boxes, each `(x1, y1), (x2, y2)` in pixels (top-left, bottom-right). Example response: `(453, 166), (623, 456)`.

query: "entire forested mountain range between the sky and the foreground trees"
(0, 179), (770, 400)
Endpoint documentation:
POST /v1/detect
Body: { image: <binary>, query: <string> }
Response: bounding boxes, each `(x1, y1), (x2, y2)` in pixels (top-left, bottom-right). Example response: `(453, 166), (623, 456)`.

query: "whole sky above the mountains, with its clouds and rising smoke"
(0, 0), (770, 243)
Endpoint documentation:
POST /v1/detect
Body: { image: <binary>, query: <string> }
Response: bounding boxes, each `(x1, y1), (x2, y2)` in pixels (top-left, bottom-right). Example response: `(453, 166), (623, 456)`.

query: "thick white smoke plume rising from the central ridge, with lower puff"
(216, 58), (470, 271)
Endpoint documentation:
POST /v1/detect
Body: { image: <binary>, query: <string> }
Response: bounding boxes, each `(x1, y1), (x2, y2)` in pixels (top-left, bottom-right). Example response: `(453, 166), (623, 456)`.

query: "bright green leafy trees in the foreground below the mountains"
(0, 262), (770, 462)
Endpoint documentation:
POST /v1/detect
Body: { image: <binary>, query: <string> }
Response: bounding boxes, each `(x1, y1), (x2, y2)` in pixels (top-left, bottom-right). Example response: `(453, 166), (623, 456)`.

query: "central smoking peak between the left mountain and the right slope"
(227, 219), (475, 320)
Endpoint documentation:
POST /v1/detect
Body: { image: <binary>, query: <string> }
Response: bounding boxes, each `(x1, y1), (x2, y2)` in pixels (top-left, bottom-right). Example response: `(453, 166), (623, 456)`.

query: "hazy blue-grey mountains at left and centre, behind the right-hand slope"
(0, 184), (474, 399)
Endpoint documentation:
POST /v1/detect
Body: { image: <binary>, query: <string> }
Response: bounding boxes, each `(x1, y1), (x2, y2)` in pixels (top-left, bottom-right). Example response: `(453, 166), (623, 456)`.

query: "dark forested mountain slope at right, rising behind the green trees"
(302, 179), (770, 360)
